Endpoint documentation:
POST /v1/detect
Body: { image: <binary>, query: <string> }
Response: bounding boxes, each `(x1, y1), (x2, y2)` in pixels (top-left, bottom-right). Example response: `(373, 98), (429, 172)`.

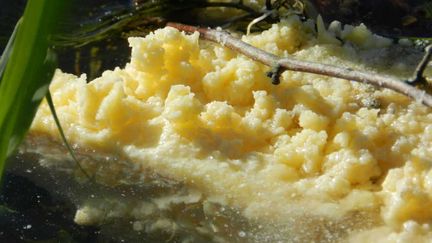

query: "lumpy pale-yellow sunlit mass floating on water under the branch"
(31, 17), (432, 242)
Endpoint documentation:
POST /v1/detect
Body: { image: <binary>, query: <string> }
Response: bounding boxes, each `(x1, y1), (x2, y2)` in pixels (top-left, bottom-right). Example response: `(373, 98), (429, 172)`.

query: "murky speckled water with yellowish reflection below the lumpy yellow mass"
(5, 138), (260, 242)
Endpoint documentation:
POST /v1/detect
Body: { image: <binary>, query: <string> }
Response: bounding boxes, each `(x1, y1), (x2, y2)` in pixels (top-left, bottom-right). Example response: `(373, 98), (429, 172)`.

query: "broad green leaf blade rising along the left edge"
(0, 0), (67, 179)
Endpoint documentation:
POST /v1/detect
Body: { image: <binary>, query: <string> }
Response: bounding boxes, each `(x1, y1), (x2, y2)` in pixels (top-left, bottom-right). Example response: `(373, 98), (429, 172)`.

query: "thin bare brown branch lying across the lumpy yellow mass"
(167, 23), (432, 107)
